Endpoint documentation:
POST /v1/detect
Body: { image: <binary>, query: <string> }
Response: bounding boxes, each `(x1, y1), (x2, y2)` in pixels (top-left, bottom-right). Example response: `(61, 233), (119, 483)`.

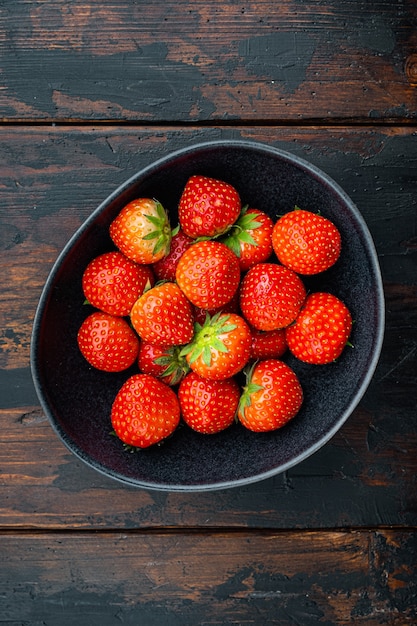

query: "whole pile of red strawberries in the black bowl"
(78, 175), (352, 448)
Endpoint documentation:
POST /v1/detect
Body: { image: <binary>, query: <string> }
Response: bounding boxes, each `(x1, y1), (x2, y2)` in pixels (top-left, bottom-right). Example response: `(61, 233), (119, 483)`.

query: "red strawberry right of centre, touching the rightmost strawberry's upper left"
(240, 263), (306, 330)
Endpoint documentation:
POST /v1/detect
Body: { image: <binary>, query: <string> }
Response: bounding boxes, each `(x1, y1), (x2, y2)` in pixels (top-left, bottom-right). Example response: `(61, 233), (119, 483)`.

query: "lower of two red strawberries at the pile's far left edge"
(77, 311), (139, 372)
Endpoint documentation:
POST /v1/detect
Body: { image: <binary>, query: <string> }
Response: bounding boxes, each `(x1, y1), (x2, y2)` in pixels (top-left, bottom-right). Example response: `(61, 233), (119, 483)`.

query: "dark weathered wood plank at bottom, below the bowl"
(0, 531), (417, 626)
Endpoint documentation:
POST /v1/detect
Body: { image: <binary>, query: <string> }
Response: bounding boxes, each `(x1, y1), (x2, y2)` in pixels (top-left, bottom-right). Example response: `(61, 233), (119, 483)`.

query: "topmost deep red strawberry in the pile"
(178, 175), (241, 238)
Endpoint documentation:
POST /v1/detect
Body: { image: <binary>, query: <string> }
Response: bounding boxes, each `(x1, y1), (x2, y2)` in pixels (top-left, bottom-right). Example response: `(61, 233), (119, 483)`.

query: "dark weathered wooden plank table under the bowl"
(0, 0), (417, 626)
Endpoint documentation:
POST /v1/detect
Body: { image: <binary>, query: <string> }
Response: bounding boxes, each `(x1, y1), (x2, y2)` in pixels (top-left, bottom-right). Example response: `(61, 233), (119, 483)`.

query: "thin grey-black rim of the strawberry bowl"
(30, 139), (385, 492)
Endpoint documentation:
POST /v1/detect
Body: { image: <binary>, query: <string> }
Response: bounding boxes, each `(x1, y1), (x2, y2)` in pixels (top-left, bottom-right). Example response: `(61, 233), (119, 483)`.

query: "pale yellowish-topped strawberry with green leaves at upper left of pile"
(110, 198), (171, 264)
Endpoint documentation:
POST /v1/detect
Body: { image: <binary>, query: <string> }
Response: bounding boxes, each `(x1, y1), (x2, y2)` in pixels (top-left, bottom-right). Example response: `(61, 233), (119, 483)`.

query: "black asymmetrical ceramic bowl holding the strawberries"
(31, 141), (384, 491)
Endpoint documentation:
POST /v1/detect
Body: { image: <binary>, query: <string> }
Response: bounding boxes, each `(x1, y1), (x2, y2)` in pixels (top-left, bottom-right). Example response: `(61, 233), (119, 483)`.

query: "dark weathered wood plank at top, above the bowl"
(0, 0), (417, 122)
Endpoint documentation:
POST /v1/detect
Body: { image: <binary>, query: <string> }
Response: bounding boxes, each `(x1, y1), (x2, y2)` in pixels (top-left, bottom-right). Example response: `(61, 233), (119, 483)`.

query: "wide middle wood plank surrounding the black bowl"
(0, 126), (417, 530)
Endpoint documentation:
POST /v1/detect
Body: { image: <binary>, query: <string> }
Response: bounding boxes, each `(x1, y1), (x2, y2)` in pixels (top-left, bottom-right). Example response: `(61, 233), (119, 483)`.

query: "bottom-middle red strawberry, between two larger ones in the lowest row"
(178, 372), (240, 435)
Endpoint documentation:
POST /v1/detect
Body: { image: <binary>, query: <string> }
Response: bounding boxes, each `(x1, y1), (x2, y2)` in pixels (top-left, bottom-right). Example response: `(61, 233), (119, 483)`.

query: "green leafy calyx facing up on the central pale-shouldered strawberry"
(180, 313), (236, 367)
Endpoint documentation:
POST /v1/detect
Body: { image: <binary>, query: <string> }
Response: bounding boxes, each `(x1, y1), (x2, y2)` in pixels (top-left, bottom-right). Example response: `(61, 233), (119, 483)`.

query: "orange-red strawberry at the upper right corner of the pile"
(272, 208), (341, 275)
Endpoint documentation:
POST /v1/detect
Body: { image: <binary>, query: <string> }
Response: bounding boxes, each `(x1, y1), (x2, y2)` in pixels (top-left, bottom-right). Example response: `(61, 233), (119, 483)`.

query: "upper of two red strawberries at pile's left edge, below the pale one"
(82, 251), (155, 317)
